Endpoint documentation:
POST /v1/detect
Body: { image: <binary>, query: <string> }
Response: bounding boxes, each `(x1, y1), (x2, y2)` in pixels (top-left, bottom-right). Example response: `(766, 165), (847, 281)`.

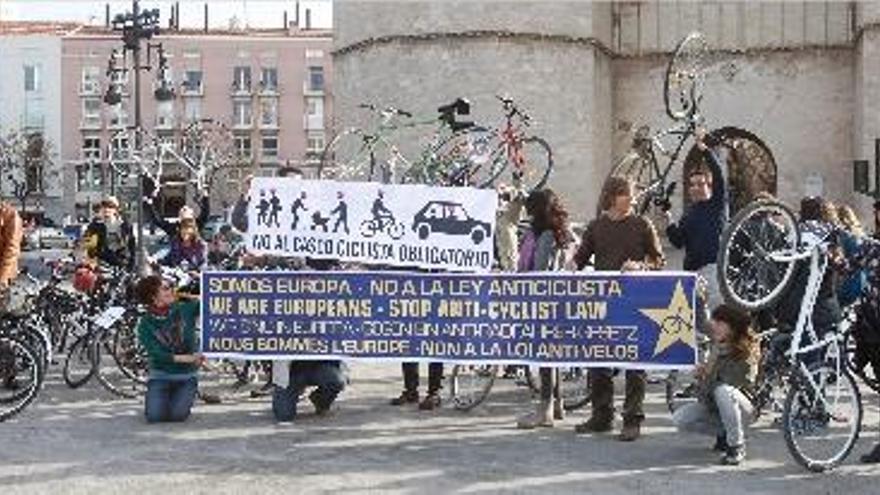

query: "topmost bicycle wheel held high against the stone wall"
(663, 32), (708, 120)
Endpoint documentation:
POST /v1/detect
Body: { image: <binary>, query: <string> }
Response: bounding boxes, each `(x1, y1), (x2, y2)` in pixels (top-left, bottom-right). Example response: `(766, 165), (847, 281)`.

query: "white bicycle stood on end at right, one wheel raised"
(718, 200), (863, 472)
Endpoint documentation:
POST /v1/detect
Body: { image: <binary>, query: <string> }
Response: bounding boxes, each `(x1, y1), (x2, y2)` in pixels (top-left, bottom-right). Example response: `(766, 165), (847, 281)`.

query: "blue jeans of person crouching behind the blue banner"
(272, 361), (347, 421)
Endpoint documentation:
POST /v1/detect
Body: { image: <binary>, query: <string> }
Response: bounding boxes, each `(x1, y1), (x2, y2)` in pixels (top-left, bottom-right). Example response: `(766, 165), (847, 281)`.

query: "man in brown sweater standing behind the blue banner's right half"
(572, 177), (664, 442)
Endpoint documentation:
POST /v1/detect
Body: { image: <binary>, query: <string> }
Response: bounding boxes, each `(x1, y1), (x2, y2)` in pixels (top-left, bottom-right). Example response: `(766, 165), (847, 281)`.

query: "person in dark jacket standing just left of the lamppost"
(83, 196), (135, 270)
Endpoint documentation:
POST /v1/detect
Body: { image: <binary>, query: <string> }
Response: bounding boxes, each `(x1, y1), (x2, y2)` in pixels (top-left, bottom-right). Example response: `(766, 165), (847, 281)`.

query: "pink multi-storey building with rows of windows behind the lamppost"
(61, 27), (332, 220)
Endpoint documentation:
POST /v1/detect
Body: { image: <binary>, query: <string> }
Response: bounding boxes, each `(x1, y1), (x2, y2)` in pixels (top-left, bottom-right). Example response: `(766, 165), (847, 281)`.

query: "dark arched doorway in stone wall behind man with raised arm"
(681, 127), (777, 216)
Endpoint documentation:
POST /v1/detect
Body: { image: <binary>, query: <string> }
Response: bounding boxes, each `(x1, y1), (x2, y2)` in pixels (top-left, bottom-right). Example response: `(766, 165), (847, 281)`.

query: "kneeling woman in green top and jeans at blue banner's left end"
(135, 275), (205, 423)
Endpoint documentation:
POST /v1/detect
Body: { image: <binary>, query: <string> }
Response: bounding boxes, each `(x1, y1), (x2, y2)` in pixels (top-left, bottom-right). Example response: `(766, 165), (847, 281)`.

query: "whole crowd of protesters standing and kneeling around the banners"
(0, 140), (880, 464)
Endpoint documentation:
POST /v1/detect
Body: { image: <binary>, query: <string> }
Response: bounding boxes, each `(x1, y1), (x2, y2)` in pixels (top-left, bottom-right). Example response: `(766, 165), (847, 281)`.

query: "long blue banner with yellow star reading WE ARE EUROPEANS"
(201, 271), (696, 369)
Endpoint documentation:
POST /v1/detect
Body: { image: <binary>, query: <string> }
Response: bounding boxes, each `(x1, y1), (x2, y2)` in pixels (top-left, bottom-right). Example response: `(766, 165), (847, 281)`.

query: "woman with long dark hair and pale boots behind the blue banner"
(516, 189), (573, 429)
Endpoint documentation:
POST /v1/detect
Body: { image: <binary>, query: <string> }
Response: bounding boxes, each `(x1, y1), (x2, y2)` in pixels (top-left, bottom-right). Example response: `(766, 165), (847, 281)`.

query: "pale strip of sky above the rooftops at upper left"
(0, 0), (333, 28)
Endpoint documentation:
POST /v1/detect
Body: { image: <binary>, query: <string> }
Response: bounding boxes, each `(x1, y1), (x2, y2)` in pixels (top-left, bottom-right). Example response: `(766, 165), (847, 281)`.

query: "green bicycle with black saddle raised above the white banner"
(317, 98), (474, 184)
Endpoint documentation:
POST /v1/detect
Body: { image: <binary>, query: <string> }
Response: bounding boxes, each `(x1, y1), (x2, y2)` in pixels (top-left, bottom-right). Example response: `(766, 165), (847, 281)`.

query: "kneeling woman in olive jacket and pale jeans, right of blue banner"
(672, 304), (759, 464)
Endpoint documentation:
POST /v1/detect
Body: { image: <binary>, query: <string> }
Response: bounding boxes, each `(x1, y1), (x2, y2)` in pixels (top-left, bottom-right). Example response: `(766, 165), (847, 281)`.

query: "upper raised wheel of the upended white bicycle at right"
(718, 201), (800, 311)
